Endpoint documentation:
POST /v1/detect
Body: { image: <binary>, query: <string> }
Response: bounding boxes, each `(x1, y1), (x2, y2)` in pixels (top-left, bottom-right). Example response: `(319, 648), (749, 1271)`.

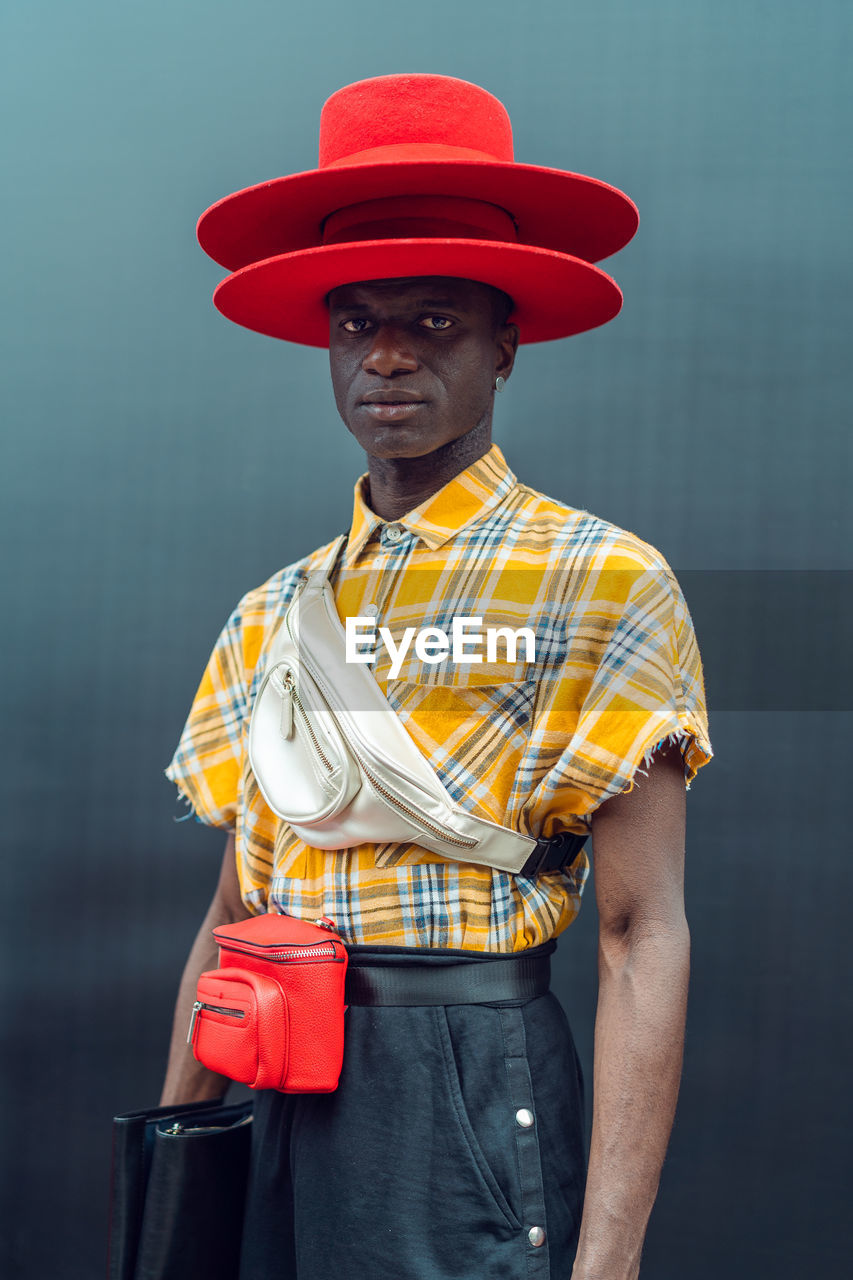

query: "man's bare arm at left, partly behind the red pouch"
(160, 836), (251, 1106)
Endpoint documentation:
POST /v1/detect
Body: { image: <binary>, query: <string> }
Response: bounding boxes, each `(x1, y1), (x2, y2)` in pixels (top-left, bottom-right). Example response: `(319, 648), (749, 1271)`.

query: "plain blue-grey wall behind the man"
(0, 0), (853, 1280)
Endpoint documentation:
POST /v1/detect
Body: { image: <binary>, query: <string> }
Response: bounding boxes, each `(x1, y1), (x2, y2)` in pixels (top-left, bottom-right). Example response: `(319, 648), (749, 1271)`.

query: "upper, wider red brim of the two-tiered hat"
(196, 160), (639, 271)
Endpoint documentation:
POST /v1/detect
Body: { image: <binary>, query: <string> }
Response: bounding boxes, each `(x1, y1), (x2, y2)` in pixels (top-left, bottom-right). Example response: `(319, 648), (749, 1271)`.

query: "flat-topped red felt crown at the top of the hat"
(319, 74), (512, 169)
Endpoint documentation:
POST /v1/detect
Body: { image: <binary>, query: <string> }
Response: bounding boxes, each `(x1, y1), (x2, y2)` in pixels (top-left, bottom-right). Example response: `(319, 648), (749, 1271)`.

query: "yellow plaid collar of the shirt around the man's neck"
(346, 444), (516, 563)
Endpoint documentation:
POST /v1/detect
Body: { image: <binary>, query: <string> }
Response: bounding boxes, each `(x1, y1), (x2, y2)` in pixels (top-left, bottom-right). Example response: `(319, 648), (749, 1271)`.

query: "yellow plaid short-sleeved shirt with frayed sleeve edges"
(165, 445), (713, 951)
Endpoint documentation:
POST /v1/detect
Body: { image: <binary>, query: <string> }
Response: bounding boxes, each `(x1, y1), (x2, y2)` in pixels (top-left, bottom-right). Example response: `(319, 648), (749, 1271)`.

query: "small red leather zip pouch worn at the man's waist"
(187, 914), (348, 1093)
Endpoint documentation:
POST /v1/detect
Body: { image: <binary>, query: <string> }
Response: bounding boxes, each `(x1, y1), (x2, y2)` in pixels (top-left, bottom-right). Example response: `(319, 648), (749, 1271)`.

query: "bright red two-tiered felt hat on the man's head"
(197, 74), (639, 347)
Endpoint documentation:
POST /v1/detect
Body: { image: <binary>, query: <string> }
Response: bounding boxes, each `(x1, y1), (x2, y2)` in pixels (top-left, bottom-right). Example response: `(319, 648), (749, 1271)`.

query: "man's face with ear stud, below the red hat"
(328, 275), (519, 458)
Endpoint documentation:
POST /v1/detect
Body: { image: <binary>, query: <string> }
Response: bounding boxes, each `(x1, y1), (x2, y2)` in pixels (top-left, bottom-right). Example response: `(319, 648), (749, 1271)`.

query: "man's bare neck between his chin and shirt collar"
(366, 422), (492, 520)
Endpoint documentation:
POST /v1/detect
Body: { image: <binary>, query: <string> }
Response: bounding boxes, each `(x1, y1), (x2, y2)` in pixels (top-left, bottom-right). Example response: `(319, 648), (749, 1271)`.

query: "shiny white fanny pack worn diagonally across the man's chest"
(242, 536), (587, 876)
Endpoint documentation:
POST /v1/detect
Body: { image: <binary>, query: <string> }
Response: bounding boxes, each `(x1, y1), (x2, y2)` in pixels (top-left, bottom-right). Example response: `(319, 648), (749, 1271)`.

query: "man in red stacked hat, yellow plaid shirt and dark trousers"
(163, 76), (711, 1280)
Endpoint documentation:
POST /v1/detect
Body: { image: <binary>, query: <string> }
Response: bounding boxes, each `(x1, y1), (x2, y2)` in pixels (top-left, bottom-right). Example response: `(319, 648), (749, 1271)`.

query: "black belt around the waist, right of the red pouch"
(345, 940), (557, 1005)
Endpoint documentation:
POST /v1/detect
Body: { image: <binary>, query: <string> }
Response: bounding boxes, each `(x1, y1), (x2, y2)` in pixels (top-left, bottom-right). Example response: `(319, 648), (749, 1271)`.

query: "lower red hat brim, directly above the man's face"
(208, 239), (622, 347)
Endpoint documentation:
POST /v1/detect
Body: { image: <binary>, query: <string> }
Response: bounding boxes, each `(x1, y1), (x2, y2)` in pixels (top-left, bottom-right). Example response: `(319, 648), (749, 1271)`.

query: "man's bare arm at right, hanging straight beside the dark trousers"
(571, 744), (690, 1280)
